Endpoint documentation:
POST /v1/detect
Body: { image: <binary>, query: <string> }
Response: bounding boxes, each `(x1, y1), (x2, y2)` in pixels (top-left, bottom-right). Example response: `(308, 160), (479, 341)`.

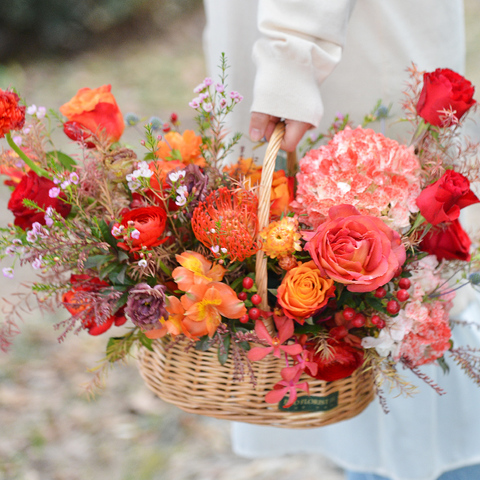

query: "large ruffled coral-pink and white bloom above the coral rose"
(292, 127), (420, 230)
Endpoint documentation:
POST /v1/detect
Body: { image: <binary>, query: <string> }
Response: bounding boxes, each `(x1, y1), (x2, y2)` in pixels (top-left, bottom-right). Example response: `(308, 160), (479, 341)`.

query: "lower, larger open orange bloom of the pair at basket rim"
(181, 282), (247, 338)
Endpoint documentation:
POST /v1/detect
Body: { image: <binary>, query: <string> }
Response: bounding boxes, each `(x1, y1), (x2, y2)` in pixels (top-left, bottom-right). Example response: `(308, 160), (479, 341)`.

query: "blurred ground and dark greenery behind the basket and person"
(0, 0), (480, 480)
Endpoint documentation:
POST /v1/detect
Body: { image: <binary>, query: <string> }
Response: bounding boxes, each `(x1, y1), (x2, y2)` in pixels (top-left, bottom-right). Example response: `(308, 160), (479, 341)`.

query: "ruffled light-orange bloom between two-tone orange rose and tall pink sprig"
(155, 130), (205, 167)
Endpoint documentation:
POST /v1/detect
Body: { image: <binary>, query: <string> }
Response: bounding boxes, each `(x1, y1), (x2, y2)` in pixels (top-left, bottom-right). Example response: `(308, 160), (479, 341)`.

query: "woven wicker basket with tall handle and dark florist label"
(139, 124), (374, 428)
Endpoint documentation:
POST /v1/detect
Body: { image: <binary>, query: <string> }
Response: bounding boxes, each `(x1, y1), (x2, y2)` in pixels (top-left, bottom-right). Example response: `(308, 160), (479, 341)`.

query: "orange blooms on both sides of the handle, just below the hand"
(224, 157), (295, 217)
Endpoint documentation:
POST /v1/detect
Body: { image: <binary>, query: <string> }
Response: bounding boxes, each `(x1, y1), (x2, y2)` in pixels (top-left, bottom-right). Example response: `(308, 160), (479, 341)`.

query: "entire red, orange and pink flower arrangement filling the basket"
(0, 63), (480, 407)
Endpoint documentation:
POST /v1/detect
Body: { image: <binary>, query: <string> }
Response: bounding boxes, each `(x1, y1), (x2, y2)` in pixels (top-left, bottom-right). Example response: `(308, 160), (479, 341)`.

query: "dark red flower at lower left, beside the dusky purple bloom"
(62, 275), (127, 335)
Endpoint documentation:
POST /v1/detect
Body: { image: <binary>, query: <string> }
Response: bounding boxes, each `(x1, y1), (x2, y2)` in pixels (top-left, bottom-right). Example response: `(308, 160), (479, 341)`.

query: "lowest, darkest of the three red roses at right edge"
(420, 220), (472, 262)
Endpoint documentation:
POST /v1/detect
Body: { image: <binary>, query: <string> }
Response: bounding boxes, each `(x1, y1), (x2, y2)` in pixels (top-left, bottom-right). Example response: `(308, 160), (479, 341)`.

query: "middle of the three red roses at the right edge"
(416, 170), (480, 225)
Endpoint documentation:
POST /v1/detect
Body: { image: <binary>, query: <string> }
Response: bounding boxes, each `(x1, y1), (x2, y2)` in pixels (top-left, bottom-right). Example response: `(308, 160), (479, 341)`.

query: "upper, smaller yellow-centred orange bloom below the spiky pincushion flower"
(172, 250), (226, 292)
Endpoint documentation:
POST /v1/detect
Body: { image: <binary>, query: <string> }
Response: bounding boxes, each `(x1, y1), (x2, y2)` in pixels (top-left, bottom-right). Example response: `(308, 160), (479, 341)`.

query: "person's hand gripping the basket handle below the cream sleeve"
(248, 112), (314, 152)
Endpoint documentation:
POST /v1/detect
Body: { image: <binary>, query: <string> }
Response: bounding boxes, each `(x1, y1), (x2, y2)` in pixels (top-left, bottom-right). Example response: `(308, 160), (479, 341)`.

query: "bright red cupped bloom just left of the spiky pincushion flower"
(118, 207), (167, 252)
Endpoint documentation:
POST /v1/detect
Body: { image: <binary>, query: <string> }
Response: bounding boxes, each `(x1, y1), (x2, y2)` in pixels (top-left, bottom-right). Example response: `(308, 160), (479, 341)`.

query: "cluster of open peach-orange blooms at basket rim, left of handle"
(145, 251), (247, 340)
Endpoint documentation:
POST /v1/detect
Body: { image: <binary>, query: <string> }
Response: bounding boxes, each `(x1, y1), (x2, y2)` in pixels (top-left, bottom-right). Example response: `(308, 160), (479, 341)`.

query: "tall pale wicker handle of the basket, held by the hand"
(255, 122), (285, 335)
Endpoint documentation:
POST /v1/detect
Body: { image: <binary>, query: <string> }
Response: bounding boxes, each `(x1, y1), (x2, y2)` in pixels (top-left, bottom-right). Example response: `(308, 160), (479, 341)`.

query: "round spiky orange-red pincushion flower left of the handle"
(192, 187), (259, 262)
